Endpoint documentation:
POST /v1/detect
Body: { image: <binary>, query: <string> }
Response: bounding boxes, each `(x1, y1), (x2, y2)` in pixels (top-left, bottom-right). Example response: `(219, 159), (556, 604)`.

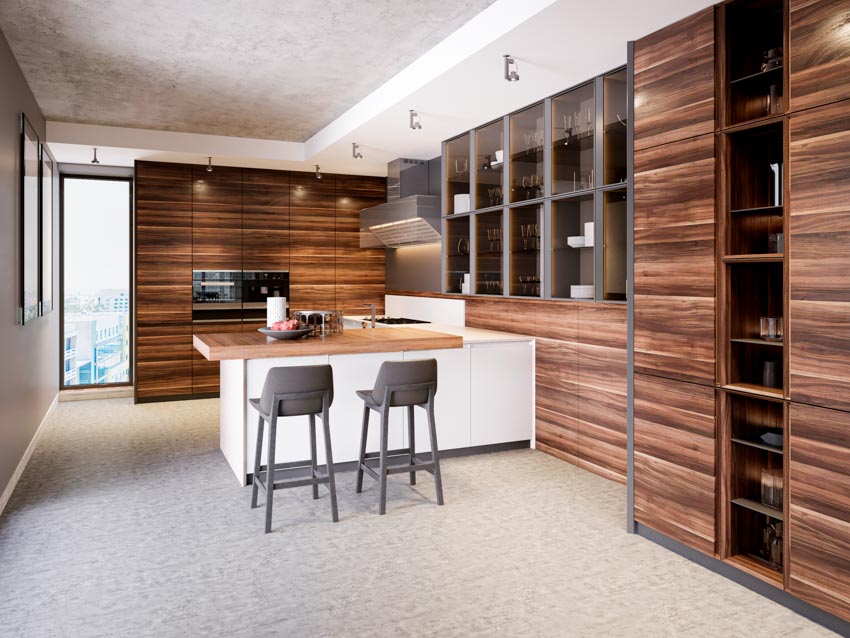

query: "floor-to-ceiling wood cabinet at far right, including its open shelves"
(633, 0), (850, 621)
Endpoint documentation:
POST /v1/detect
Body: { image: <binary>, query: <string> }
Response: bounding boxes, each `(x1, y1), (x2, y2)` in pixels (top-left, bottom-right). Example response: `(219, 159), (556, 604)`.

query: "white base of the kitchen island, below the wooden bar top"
(215, 336), (534, 486)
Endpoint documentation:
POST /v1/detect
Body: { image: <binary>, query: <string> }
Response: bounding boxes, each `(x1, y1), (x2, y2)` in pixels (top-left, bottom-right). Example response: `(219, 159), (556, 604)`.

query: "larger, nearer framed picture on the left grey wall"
(20, 113), (41, 324)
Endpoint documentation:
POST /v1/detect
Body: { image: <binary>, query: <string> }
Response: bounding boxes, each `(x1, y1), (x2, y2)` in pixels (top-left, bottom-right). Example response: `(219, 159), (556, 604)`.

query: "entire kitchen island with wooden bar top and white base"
(193, 324), (534, 485)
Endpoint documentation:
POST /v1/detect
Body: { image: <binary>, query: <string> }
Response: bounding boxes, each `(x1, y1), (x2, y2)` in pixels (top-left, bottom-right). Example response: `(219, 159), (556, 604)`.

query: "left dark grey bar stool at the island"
(249, 365), (339, 534)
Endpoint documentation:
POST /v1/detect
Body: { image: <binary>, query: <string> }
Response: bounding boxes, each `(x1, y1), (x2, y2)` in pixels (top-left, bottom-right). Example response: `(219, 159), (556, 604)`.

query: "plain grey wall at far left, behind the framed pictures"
(0, 28), (59, 500)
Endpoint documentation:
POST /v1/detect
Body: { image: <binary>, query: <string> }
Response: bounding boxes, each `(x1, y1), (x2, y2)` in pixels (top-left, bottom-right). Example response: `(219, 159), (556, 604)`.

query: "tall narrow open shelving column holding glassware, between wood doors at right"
(717, 0), (788, 587)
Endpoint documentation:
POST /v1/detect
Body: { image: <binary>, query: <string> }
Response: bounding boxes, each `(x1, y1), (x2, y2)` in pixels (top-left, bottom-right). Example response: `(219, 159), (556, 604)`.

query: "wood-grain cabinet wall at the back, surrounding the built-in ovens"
(135, 162), (386, 401)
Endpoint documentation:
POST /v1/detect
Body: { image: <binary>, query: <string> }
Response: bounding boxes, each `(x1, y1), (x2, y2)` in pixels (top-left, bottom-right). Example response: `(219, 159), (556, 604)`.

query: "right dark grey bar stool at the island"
(357, 359), (443, 514)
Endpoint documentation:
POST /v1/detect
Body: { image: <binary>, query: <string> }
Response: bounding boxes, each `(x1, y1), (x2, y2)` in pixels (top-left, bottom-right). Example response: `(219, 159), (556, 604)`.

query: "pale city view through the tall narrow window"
(63, 177), (131, 386)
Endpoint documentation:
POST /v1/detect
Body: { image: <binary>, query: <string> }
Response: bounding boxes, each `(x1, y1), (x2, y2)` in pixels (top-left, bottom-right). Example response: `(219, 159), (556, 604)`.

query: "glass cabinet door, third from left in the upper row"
(510, 102), (544, 203)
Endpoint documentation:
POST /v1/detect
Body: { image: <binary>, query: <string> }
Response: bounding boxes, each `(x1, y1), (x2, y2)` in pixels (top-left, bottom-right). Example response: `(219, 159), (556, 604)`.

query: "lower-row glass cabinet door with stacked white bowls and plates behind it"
(551, 194), (595, 299)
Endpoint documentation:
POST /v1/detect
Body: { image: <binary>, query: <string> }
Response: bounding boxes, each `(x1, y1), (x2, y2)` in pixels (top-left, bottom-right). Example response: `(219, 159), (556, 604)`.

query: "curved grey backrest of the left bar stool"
(260, 365), (334, 416)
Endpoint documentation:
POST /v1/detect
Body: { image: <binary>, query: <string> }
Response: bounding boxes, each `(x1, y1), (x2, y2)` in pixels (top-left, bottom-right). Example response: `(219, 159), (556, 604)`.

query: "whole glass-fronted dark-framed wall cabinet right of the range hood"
(443, 68), (629, 301)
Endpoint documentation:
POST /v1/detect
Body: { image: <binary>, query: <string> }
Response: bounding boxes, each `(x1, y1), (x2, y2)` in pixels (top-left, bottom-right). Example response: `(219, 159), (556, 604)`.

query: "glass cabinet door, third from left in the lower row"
(510, 204), (543, 297)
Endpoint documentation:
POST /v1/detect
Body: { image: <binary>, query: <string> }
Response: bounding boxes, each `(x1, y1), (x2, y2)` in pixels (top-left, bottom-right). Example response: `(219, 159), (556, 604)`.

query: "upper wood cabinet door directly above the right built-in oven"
(242, 169), (289, 271)
